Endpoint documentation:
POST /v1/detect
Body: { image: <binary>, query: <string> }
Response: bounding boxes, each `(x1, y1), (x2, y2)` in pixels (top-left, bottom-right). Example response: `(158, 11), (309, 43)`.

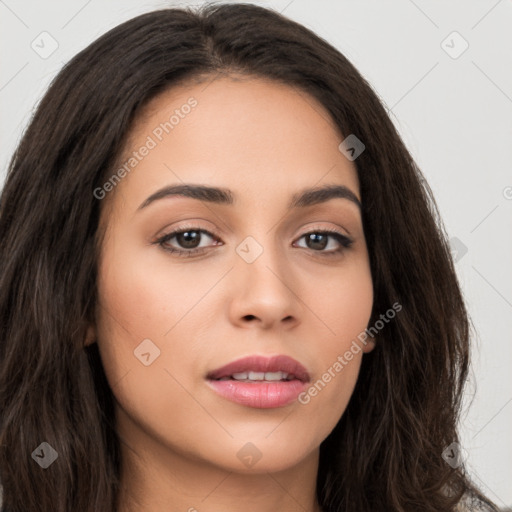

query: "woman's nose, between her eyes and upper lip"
(228, 241), (304, 329)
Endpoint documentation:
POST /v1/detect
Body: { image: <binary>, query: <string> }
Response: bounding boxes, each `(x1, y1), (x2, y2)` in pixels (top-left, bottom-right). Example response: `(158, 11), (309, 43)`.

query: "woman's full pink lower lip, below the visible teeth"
(207, 379), (307, 409)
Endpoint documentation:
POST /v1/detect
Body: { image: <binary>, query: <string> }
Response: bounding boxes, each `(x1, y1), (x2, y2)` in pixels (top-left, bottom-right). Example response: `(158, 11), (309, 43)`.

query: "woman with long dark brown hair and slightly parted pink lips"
(0, 4), (497, 512)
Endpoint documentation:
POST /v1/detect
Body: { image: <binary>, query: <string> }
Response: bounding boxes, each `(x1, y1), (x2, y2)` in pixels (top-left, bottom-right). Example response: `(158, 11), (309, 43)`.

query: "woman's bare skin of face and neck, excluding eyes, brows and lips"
(86, 73), (373, 512)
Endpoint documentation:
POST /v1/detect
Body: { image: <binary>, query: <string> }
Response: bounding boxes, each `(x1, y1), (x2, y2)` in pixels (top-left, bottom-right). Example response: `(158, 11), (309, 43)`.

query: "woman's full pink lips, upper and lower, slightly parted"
(206, 355), (309, 409)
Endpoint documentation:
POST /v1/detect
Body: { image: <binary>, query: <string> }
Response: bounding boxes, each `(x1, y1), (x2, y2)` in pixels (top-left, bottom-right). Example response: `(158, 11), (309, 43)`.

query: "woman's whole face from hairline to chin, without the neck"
(87, 78), (373, 472)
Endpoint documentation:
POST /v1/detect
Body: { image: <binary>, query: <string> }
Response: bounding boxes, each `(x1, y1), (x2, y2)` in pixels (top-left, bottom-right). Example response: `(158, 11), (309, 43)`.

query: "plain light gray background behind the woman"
(0, 0), (512, 507)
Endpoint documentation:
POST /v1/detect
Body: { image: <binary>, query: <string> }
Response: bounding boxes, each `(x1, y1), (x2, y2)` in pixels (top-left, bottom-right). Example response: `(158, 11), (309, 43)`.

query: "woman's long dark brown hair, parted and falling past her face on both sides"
(0, 4), (497, 512)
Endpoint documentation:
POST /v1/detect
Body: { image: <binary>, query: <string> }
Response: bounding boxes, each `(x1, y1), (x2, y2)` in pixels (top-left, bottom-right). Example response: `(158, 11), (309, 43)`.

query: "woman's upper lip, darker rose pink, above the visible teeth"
(207, 355), (309, 382)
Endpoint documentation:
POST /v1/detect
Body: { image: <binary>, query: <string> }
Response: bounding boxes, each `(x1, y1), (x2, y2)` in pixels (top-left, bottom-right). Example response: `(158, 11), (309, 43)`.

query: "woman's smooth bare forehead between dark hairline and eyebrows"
(104, 77), (359, 214)
